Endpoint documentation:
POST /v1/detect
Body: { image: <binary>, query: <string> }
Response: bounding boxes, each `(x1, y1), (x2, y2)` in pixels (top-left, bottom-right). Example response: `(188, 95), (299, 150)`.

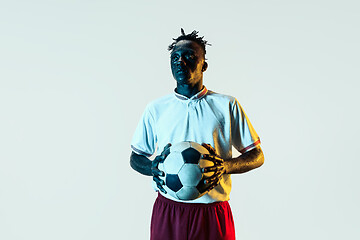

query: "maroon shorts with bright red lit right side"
(150, 194), (235, 240)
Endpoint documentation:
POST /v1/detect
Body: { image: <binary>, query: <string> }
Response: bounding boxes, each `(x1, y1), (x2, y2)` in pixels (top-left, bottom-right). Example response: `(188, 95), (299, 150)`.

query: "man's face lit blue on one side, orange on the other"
(170, 40), (207, 86)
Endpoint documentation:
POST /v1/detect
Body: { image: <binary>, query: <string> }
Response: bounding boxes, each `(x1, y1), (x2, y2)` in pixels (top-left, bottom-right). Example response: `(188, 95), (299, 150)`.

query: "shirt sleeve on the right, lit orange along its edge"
(231, 99), (260, 153)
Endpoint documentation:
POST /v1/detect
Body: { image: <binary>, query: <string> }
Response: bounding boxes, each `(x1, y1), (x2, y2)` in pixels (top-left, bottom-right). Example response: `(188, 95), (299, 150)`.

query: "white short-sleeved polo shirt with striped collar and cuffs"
(131, 86), (260, 203)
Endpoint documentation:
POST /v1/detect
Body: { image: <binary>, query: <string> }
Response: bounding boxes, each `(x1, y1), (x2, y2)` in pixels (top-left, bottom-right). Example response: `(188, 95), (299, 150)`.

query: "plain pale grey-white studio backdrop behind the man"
(0, 0), (360, 240)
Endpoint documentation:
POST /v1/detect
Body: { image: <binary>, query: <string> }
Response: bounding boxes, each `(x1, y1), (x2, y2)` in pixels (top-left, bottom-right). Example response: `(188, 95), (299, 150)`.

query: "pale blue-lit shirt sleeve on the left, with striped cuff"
(131, 106), (156, 157)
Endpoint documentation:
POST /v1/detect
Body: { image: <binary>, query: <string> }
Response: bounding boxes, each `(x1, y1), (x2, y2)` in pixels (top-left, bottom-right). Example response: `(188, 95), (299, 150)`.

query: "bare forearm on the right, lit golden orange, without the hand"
(224, 146), (264, 174)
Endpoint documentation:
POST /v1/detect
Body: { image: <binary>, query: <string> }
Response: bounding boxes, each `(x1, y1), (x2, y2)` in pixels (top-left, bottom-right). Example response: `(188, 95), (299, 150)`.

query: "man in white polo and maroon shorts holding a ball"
(130, 29), (264, 240)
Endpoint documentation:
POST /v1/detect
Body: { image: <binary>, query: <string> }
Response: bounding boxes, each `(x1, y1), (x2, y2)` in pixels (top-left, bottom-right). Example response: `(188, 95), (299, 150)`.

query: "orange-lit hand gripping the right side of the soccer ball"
(201, 143), (225, 191)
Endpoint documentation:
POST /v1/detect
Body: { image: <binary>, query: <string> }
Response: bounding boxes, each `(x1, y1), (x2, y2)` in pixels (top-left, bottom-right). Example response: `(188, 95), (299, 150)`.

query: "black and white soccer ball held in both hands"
(158, 142), (214, 201)
